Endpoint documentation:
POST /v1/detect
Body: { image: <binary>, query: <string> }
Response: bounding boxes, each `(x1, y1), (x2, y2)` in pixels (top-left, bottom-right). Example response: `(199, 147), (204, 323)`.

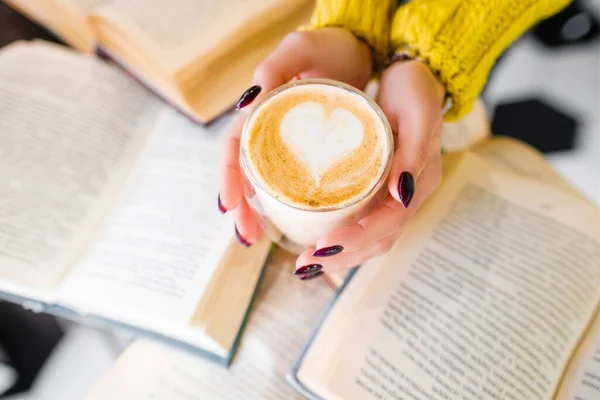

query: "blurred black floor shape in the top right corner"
(532, 0), (600, 48)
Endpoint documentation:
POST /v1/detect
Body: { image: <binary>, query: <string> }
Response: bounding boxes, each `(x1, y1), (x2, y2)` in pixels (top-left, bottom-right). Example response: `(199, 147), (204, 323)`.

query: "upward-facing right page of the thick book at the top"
(95, 0), (308, 69)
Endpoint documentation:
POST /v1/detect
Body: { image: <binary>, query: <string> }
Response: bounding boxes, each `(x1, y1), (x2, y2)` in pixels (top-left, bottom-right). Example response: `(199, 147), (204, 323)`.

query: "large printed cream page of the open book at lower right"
(298, 154), (600, 400)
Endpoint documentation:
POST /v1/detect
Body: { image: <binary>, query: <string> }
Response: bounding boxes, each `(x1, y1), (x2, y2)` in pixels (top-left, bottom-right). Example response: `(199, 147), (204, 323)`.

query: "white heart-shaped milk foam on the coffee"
(279, 102), (365, 185)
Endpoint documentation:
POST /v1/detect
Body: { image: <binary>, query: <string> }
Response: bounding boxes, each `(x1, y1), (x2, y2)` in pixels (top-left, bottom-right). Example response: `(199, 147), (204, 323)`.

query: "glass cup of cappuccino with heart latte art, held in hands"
(241, 80), (393, 252)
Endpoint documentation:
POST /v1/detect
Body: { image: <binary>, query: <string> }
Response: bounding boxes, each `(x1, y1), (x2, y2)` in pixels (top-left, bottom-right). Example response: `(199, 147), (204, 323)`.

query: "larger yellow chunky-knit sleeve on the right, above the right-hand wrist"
(391, 0), (570, 120)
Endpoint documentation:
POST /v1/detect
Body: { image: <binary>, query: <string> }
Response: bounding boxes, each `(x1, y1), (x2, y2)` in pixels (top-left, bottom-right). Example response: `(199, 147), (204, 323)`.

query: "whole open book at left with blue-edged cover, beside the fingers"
(0, 42), (270, 363)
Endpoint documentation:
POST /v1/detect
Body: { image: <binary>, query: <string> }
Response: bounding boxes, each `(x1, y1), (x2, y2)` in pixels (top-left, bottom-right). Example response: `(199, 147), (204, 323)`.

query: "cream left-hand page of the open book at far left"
(0, 42), (159, 295)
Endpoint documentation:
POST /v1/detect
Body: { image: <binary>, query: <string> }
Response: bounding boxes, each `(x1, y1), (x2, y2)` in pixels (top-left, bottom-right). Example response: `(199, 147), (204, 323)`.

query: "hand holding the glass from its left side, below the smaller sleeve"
(219, 28), (373, 245)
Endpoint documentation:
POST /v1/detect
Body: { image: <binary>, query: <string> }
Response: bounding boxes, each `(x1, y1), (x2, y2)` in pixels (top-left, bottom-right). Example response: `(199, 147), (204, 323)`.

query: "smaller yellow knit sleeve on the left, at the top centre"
(301, 0), (395, 70)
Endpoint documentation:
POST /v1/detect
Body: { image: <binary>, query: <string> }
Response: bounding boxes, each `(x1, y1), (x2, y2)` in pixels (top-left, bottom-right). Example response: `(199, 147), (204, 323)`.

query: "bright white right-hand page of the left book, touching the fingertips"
(59, 109), (233, 342)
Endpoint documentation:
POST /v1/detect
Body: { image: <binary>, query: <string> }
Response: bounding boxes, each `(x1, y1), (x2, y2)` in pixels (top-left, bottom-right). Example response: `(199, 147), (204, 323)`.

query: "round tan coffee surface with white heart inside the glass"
(243, 84), (388, 209)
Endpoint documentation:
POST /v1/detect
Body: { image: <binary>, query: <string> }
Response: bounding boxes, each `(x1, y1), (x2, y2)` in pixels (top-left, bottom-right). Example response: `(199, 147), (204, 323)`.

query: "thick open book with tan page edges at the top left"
(4, 0), (314, 122)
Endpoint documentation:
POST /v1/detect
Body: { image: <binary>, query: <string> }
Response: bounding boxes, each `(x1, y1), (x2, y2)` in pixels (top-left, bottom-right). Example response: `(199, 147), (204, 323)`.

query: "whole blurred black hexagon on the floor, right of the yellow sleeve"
(492, 98), (578, 153)
